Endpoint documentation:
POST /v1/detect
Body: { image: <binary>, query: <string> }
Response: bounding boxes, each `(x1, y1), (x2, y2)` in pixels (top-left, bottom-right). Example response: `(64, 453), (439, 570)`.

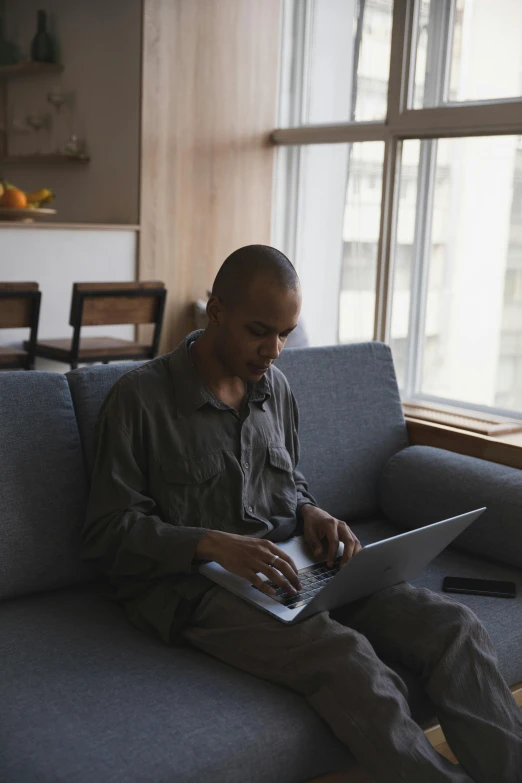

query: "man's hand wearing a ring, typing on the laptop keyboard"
(196, 530), (301, 595)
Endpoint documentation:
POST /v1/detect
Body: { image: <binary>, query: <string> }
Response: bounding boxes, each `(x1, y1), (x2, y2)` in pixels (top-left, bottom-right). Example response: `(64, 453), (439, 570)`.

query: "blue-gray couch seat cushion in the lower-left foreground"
(0, 587), (354, 783)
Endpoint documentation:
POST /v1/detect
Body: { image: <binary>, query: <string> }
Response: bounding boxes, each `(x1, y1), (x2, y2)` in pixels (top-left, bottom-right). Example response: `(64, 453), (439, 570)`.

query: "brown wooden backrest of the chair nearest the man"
(69, 281), (166, 327)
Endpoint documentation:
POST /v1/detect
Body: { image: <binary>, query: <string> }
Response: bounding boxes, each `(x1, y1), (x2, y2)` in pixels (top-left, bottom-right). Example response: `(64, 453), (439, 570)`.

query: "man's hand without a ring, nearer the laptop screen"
(301, 503), (362, 568)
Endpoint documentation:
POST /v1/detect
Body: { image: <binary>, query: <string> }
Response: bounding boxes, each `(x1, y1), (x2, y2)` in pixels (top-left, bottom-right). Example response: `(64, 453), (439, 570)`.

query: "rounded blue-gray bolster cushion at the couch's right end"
(379, 446), (522, 567)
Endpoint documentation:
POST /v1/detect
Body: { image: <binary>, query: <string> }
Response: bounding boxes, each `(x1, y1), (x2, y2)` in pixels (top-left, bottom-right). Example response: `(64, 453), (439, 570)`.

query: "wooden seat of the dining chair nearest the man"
(24, 337), (151, 362)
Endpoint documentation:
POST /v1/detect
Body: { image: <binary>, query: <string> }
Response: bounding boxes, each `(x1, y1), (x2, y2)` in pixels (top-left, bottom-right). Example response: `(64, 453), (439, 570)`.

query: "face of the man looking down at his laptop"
(210, 275), (301, 382)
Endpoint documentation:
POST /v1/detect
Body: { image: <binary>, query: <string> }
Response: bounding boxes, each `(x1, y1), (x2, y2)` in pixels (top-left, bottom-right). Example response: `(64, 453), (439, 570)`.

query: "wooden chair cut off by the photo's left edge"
(0, 283), (42, 370)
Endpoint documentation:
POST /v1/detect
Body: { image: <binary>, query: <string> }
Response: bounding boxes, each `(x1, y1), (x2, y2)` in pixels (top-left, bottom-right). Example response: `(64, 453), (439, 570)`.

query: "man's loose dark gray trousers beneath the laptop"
(182, 582), (522, 783)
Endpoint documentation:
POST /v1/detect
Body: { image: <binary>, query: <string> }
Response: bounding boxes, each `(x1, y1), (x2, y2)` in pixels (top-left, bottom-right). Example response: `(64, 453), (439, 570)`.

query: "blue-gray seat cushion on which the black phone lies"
(350, 519), (522, 685)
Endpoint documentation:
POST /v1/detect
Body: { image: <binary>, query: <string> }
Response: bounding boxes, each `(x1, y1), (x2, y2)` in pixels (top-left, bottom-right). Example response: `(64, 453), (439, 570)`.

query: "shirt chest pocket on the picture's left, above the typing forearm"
(158, 452), (224, 527)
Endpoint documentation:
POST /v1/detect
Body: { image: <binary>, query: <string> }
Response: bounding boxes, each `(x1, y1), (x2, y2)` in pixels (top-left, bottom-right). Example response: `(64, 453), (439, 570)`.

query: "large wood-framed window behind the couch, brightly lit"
(273, 0), (522, 418)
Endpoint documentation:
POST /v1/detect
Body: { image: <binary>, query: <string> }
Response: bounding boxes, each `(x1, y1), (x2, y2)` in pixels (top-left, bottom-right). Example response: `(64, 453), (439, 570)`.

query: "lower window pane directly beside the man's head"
(274, 142), (384, 345)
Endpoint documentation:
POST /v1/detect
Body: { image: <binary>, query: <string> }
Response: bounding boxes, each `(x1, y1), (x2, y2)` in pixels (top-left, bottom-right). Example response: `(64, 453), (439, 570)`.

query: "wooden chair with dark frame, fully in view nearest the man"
(24, 282), (167, 370)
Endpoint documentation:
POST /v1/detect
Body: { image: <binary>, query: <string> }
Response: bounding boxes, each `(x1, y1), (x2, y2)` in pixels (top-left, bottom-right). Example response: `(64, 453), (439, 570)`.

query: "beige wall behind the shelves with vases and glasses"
(0, 0), (141, 224)
